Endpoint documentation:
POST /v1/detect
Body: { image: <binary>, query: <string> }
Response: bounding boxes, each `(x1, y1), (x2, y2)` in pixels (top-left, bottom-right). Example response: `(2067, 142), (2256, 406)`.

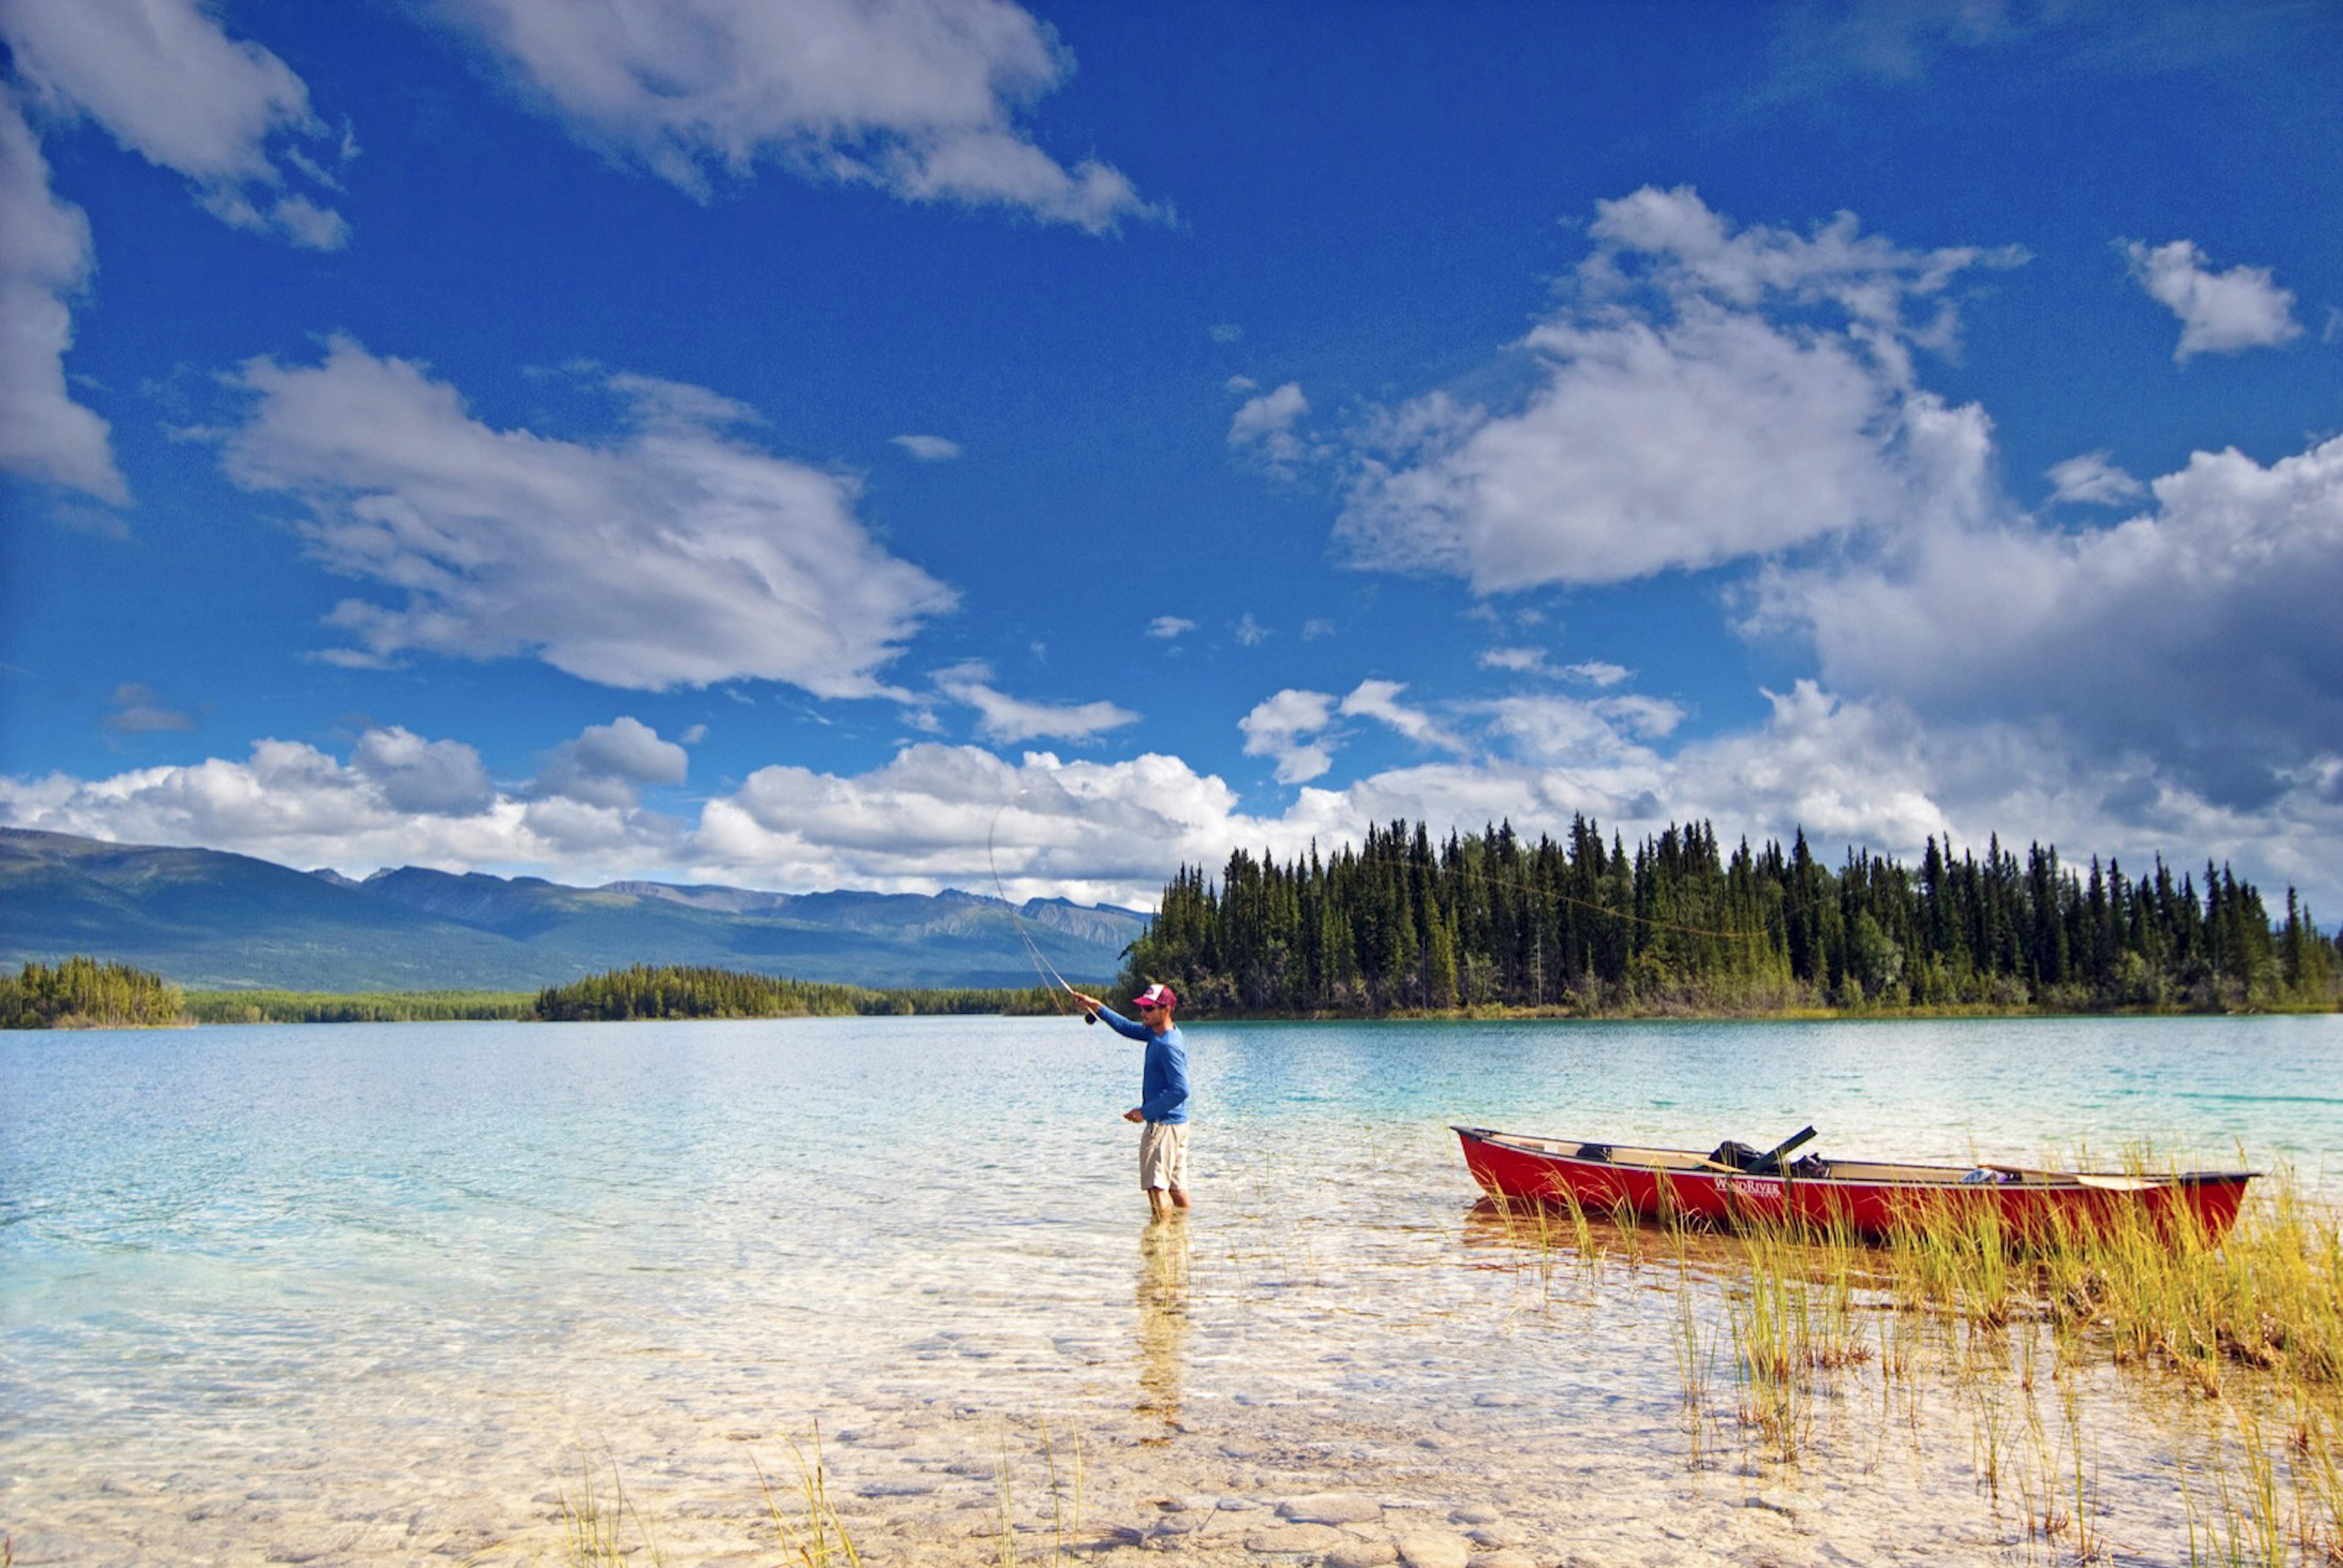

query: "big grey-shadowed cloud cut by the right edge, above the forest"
(1752, 438), (2343, 808)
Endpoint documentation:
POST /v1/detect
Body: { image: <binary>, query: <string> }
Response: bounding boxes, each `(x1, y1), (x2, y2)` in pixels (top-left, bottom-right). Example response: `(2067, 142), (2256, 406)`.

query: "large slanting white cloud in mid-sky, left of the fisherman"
(220, 337), (954, 696)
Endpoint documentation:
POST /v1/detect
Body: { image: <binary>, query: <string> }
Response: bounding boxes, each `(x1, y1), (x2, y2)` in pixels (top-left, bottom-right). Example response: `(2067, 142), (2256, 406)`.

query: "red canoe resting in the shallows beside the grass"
(1455, 1127), (2259, 1240)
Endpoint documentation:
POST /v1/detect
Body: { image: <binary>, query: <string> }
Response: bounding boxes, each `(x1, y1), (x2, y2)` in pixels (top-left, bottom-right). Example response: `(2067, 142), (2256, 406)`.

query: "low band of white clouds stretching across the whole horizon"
(0, 680), (2343, 912)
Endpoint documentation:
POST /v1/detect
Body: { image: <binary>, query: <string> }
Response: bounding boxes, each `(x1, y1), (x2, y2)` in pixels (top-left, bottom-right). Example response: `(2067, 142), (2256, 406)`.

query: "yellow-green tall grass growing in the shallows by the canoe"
(1630, 1158), (2343, 1568)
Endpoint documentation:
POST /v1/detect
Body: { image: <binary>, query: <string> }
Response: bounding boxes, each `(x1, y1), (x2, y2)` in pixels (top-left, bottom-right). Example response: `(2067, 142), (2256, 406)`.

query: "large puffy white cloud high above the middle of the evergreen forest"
(1338, 187), (2022, 593)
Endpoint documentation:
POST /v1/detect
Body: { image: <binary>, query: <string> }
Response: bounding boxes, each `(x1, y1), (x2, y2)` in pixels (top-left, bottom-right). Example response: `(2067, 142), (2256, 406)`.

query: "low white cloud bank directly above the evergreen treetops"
(1265, 680), (2343, 914)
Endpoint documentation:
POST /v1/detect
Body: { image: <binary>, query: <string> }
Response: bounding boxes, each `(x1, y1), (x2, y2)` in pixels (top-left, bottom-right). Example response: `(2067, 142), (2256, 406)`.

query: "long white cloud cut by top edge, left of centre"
(438, 0), (1169, 234)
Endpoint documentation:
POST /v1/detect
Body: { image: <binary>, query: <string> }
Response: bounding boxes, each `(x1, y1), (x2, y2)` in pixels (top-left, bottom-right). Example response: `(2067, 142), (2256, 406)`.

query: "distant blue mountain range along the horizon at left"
(0, 827), (1148, 991)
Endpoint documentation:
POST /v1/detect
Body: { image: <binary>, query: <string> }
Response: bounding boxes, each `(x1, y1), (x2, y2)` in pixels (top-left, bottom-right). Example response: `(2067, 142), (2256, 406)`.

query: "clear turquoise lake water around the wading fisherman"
(0, 1017), (2343, 1568)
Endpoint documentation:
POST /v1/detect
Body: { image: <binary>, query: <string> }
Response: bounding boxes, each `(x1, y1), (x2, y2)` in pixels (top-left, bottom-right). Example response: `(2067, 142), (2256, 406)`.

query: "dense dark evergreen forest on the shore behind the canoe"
(1122, 818), (2343, 1017)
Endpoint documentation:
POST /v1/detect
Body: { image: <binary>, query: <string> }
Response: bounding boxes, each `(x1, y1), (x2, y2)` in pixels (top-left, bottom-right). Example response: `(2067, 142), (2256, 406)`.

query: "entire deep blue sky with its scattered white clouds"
(0, 0), (2343, 919)
